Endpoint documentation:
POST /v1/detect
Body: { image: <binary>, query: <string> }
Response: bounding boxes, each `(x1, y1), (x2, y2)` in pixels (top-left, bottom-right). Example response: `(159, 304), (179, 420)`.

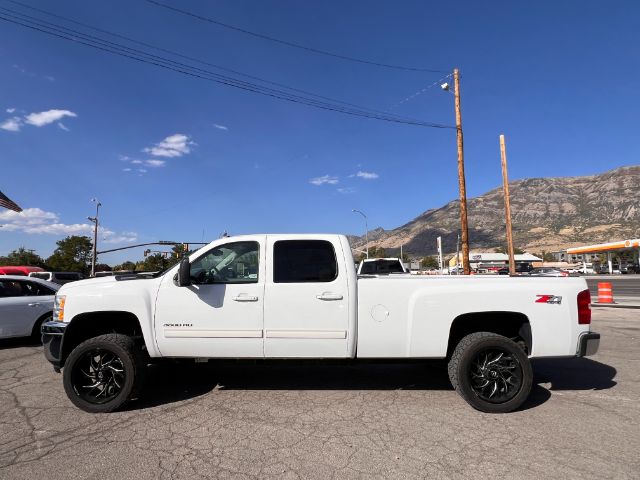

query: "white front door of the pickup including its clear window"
(154, 237), (265, 358)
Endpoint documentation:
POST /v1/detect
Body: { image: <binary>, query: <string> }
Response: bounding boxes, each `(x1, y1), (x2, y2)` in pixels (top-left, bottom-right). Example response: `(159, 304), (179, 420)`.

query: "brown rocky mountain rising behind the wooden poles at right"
(350, 166), (640, 257)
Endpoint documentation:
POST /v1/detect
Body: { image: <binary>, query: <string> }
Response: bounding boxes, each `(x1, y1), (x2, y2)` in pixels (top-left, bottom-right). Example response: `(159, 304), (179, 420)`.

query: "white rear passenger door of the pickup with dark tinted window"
(264, 237), (349, 358)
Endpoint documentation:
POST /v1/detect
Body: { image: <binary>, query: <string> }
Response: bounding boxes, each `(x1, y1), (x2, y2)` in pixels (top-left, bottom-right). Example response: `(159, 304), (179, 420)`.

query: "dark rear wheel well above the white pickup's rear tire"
(447, 311), (533, 358)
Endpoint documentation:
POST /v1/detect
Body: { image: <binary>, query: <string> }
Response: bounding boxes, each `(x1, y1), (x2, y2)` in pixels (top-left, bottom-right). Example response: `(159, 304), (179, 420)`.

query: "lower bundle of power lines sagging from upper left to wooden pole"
(0, 8), (454, 128)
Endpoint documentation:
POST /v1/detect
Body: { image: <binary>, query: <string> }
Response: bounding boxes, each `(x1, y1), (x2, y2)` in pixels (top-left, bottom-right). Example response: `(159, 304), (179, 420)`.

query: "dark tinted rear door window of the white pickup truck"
(273, 240), (338, 283)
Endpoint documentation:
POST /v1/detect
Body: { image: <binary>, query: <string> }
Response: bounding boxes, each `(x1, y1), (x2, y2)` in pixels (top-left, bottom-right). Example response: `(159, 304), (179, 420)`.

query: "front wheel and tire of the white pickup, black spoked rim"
(62, 333), (146, 413)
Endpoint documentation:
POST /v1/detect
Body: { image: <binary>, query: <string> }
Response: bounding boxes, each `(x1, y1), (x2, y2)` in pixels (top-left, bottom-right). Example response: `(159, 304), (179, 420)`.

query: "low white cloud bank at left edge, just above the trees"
(0, 208), (138, 243)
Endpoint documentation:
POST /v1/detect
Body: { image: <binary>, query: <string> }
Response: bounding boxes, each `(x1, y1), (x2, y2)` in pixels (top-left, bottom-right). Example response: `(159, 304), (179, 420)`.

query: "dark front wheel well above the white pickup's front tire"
(60, 311), (144, 367)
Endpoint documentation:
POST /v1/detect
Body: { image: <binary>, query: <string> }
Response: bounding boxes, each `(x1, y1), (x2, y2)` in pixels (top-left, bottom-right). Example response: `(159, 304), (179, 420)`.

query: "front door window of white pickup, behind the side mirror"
(191, 242), (260, 285)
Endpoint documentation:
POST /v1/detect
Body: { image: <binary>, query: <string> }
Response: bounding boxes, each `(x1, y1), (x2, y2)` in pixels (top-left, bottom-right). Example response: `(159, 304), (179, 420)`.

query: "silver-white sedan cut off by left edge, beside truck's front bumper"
(0, 275), (60, 341)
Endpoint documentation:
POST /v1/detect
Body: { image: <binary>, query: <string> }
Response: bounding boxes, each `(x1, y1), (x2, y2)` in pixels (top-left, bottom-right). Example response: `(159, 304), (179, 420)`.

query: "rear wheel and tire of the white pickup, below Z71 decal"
(448, 332), (533, 413)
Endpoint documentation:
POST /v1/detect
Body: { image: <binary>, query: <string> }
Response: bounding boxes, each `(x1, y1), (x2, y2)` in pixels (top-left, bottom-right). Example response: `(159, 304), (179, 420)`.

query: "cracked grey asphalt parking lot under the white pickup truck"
(0, 308), (640, 480)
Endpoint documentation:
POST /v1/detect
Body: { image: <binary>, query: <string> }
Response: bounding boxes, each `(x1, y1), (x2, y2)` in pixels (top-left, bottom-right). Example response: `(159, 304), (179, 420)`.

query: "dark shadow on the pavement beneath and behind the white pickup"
(128, 358), (616, 410)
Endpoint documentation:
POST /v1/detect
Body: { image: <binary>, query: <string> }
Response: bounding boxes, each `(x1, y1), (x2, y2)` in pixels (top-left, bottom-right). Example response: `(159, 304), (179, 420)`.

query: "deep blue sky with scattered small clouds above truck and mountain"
(0, 0), (640, 264)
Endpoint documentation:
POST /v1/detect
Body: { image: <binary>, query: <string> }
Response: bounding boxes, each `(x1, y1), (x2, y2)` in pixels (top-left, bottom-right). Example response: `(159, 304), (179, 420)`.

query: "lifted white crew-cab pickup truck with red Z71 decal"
(42, 234), (600, 412)
